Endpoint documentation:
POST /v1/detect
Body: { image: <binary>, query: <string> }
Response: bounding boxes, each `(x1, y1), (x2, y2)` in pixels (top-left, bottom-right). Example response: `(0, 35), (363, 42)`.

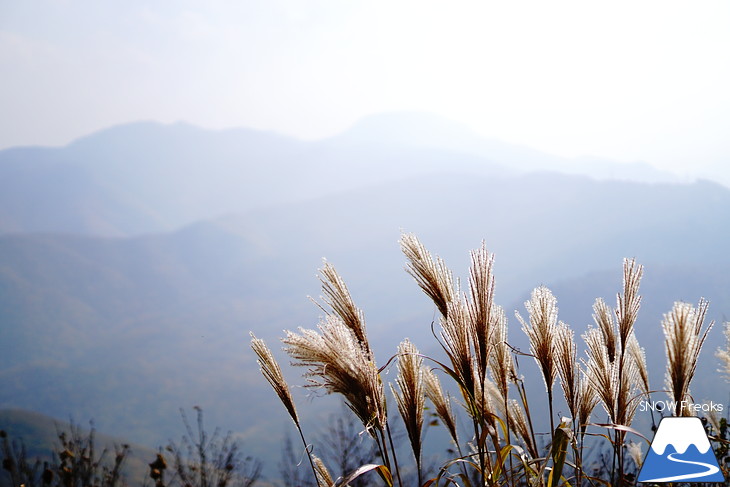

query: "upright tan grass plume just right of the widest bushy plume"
(391, 339), (426, 473)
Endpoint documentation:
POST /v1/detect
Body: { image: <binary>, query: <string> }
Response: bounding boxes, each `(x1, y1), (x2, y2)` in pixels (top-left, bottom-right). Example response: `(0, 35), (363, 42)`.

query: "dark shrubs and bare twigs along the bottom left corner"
(0, 408), (261, 487)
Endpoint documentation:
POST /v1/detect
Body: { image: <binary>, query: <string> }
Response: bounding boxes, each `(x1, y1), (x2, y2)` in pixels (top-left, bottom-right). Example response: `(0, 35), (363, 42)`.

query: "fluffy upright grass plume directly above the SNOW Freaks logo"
(662, 299), (714, 416)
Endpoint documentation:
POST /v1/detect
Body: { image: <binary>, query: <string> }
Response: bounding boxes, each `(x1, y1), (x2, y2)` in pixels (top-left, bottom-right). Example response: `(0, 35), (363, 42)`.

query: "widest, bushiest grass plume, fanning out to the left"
(282, 315), (386, 433)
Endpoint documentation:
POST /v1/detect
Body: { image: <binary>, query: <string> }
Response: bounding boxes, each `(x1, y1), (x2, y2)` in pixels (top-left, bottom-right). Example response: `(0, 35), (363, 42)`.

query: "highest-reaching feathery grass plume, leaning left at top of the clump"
(400, 233), (456, 317)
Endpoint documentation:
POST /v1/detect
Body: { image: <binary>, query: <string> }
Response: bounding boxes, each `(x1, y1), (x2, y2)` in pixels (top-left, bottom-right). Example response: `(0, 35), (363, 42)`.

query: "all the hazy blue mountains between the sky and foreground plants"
(0, 114), (730, 478)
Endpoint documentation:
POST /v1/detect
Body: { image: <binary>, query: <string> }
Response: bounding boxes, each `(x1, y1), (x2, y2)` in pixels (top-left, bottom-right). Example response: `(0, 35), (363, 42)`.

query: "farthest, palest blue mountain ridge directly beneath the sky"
(0, 113), (684, 236)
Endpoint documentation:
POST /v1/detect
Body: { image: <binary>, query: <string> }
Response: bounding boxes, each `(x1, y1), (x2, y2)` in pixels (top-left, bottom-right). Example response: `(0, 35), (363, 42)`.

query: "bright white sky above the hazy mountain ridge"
(0, 0), (730, 179)
